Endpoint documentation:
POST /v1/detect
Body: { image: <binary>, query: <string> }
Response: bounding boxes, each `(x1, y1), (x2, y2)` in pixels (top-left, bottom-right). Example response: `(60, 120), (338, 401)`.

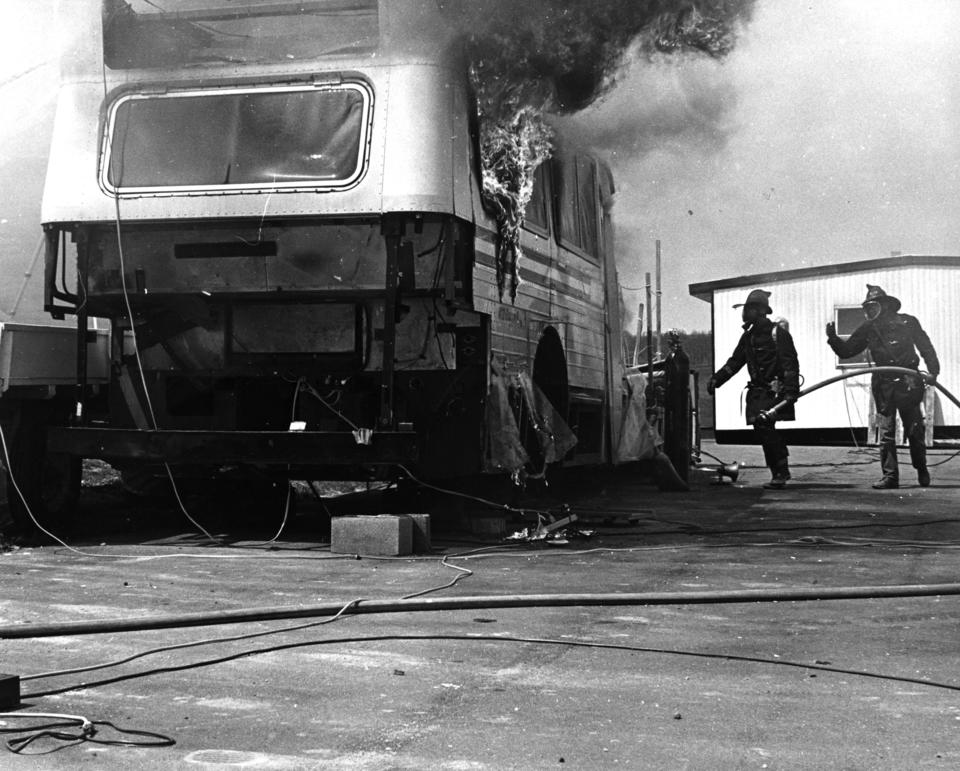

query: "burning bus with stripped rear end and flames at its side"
(0, 0), (636, 518)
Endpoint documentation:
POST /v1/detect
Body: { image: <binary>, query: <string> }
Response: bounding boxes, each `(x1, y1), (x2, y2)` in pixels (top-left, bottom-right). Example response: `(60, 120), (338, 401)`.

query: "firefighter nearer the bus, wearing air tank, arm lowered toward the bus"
(707, 289), (800, 490)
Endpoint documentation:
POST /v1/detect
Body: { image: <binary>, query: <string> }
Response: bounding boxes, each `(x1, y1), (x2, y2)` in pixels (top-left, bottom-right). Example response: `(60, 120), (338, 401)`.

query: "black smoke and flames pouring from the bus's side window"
(458, 0), (754, 299)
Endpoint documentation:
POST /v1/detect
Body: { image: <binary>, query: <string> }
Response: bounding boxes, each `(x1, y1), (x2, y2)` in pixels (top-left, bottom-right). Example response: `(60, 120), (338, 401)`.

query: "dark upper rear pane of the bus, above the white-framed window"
(103, 0), (380, 69)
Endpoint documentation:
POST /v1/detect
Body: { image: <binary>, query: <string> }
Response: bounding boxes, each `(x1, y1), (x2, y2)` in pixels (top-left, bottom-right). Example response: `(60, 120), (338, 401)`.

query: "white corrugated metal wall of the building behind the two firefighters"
(713, 266), (960, 431)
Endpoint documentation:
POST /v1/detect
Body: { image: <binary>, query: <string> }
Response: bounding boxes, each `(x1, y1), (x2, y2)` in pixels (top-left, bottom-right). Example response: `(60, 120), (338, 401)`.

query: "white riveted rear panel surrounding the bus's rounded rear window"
(41, 64), (473, 223)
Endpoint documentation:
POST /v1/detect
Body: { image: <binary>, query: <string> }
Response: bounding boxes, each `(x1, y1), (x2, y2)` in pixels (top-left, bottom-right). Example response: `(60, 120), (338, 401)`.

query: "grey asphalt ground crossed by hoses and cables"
(0, 445), (960, 770)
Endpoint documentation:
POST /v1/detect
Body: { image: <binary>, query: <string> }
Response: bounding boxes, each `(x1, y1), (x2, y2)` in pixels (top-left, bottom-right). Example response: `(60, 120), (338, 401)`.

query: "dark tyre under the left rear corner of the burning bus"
(6, 402), (82, 531)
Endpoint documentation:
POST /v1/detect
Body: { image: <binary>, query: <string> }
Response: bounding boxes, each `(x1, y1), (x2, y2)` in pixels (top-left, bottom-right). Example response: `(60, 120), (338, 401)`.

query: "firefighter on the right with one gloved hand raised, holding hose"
(827, 284), (940, 490)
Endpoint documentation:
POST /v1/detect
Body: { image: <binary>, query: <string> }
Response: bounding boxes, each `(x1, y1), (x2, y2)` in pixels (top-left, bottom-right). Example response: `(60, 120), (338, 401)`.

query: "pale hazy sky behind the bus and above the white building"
(0, 0), (960, 331)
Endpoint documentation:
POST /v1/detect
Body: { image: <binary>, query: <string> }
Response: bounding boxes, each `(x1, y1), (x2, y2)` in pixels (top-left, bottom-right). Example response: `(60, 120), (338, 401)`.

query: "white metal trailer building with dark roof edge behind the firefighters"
(689, 255), (960, 445)
